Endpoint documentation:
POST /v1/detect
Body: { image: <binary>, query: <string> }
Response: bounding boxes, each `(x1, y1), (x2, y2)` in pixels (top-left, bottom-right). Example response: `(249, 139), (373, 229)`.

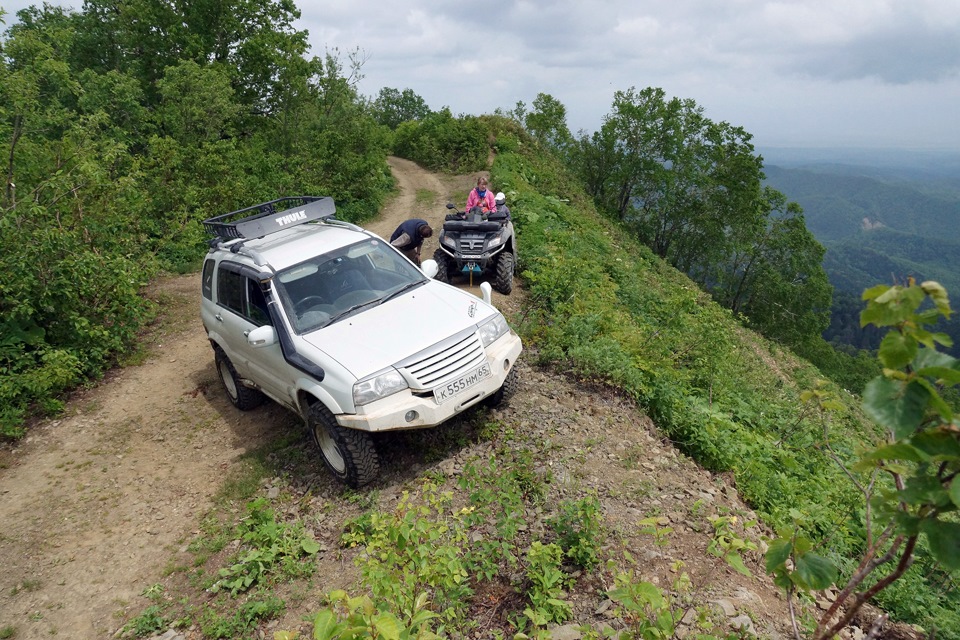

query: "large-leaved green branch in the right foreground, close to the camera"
(766, 279), (960, 640)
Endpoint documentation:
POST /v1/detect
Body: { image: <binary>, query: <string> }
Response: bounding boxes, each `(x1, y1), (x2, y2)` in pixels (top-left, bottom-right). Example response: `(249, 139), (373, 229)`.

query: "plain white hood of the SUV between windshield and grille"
(302, 281), (497, 379)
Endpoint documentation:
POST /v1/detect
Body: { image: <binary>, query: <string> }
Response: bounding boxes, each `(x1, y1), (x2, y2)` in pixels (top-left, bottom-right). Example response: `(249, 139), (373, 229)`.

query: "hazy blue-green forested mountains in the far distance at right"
(764, 153), (960, 351)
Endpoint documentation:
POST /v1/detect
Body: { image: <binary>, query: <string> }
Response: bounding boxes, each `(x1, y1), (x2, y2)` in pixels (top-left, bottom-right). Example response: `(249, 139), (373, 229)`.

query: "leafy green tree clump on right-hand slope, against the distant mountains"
(571, 88), (831, 344)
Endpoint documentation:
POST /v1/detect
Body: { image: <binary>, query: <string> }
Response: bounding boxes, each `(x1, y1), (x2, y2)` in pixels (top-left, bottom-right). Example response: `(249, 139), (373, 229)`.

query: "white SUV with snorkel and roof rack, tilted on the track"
(201, 196), (522, 487)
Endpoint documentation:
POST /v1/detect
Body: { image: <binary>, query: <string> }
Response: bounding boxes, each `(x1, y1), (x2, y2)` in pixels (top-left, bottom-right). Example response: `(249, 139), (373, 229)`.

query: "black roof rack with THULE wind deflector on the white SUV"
(203, 196), (337, 240)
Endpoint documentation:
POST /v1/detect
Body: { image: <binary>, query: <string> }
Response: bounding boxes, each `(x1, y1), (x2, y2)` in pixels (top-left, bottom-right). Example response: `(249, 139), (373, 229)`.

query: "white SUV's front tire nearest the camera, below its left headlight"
(307, 402), (380, 489)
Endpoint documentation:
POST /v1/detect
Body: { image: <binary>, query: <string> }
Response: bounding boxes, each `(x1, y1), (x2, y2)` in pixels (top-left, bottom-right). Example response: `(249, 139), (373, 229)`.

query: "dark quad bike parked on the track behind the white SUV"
(433, 204), (517, 295)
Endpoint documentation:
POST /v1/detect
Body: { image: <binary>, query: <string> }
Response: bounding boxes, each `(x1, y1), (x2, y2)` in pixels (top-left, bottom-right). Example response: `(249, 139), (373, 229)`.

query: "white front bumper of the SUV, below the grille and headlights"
(336, 331), (522, 431)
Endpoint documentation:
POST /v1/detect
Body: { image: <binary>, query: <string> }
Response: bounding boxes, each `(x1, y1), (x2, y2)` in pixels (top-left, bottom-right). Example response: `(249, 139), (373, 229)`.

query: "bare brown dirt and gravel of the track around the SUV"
(0, 159), (908, 638)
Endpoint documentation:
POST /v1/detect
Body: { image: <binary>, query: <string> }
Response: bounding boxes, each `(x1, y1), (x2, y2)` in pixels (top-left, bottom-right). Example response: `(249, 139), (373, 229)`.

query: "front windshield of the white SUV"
(274, 238), (427, 333)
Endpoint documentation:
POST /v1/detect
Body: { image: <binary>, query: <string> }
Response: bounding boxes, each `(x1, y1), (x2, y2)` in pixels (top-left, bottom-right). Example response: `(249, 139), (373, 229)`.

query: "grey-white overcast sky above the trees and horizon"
(0, 0), (960, 150)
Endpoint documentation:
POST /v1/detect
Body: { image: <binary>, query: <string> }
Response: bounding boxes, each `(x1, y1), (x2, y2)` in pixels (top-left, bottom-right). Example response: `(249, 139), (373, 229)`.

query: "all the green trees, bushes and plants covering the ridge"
(0, 0), (960, 638)
